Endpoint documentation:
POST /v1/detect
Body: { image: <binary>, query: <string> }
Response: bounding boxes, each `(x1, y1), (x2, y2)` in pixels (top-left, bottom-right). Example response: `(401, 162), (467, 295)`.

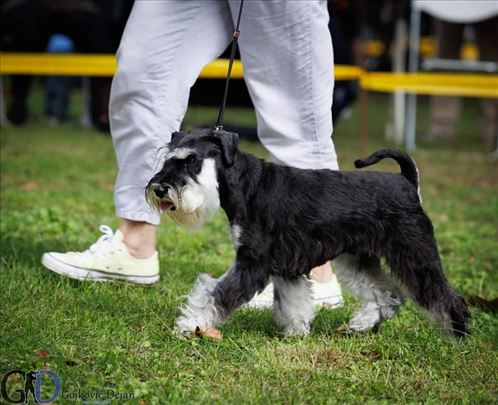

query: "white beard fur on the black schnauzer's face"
(168, 159), (220, 230)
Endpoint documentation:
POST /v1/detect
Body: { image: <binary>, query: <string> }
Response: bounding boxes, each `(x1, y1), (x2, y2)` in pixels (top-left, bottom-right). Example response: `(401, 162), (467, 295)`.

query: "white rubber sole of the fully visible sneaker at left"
(41, 253), (159, 284)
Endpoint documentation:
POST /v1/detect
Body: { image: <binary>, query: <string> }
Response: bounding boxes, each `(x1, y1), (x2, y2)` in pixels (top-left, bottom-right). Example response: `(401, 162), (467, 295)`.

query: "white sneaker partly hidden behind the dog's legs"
(244, 273), (344, 309)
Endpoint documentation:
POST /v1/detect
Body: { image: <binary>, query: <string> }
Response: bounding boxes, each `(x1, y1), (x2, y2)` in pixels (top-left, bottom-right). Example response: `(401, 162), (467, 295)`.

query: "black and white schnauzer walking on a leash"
(146, 129), (470, 337)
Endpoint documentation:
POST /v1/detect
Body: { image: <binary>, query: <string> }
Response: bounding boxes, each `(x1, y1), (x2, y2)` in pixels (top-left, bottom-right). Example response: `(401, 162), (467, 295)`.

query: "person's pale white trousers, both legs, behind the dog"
(110, 0), (337, 224)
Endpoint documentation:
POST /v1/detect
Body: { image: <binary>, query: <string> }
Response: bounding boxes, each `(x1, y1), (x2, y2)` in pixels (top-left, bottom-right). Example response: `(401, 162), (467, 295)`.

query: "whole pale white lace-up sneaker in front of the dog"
(42, 225), (159, 284)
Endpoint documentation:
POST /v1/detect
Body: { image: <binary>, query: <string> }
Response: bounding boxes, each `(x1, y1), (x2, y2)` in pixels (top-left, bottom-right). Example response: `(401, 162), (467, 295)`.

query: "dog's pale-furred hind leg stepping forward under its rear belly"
(334, 254), (402, 332)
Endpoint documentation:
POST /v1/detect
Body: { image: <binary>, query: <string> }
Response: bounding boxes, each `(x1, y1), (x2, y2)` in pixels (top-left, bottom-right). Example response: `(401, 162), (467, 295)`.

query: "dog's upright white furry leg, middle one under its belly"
(272, 276), (315, 336)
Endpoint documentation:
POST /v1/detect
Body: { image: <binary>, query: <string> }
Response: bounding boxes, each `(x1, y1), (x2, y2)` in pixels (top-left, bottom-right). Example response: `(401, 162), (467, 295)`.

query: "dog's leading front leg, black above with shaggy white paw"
(175, 263), (268, 334)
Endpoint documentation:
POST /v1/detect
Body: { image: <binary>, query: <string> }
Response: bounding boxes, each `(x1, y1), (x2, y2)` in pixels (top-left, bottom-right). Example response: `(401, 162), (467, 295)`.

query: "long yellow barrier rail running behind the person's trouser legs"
(0, 53), (498, 98)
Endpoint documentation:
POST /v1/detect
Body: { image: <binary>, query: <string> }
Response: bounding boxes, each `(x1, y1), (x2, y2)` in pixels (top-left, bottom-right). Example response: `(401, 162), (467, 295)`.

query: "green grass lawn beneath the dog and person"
(0, 96), (498, 404)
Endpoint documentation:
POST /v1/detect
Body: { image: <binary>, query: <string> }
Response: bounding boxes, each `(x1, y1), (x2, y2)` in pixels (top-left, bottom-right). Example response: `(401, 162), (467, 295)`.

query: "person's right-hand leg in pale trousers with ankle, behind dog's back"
(230, 0), (340, 302)
